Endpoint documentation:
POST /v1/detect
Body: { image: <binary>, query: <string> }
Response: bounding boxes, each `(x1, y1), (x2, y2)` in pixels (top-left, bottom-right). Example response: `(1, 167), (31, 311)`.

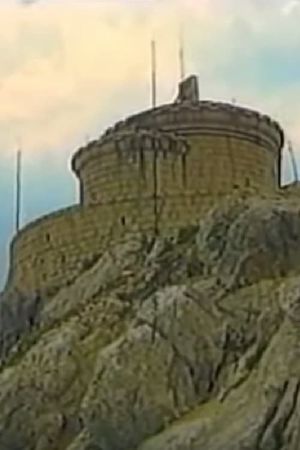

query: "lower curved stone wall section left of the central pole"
(8, 202), (157, 293)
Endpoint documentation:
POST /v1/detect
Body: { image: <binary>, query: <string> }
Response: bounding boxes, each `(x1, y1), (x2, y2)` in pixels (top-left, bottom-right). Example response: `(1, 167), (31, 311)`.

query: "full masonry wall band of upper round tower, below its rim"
(80, 129), (277, 210)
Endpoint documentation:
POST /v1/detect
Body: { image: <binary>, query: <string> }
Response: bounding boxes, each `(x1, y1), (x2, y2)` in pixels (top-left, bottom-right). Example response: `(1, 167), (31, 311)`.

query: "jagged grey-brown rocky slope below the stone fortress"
(0, 200), (300, 450)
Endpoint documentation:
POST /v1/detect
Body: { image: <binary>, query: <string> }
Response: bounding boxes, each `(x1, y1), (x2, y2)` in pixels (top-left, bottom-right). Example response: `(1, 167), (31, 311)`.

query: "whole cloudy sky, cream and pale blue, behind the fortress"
(0, 0), (300, 287)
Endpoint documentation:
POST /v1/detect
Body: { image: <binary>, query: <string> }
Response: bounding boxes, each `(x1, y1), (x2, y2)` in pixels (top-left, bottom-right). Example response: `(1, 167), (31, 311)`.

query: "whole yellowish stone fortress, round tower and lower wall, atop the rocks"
(7, 76), (296, 295)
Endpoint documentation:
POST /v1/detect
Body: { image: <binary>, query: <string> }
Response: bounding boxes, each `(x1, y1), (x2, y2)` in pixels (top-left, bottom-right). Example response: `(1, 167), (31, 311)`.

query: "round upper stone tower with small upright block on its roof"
(72, 76), (284, 226)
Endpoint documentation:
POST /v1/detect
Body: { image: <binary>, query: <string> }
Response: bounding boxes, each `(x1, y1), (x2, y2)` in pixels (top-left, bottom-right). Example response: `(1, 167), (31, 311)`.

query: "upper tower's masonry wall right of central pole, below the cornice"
(159, 136), (276, 197)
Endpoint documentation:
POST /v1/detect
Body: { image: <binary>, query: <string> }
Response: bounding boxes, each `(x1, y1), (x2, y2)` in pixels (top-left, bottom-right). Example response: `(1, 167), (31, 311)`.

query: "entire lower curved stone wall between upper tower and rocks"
(7, 196), (223, 294)
